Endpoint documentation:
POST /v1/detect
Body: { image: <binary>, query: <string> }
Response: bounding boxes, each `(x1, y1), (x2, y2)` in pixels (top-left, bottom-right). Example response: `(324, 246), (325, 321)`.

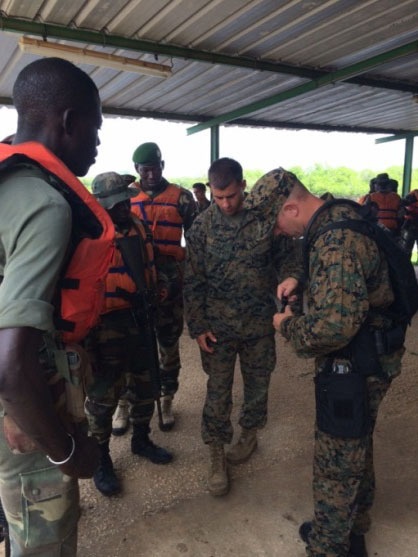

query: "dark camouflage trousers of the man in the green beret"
(156, 295), (184, 395)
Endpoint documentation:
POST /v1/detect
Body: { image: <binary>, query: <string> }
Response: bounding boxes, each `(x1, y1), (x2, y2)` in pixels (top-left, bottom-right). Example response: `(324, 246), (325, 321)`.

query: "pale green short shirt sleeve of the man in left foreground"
(0, 165), (71, 331)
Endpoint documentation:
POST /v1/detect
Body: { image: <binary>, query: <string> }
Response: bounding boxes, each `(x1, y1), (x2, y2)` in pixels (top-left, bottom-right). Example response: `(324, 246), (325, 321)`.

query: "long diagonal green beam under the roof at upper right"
(187, 41), (418, 135)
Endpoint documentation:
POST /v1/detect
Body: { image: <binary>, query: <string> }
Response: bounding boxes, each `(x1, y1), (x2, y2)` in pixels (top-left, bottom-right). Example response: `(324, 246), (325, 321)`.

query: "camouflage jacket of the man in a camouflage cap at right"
(280, 198), (393, 357)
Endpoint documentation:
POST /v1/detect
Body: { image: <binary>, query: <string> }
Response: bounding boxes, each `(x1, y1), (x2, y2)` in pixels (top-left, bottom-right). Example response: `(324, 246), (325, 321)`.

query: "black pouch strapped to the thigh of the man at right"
(315, 372), (370, 439)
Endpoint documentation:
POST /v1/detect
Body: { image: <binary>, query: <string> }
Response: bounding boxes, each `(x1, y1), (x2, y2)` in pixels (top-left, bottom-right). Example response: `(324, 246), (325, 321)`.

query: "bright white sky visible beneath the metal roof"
(0, 107), (418, 179)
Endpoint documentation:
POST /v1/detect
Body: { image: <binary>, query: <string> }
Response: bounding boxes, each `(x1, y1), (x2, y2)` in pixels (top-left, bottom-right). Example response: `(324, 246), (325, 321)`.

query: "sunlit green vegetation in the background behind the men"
(82, 164), (418, 199)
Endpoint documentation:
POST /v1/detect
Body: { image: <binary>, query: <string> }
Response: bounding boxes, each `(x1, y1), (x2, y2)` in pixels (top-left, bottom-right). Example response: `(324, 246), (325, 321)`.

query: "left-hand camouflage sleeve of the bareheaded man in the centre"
(183, 213), (210, 338)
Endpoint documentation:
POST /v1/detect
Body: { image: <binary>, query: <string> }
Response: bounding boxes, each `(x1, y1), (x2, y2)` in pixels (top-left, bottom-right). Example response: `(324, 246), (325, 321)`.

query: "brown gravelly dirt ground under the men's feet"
(72, 319), (418, 557)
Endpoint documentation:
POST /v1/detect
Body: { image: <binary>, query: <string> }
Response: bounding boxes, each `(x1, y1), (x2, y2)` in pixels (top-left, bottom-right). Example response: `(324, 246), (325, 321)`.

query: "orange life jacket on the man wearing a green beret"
(131, 184), (185, 261)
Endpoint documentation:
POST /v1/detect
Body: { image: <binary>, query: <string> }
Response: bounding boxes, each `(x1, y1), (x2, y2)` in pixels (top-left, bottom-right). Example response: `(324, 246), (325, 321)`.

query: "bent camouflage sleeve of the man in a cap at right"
(280, 231), (370, 358)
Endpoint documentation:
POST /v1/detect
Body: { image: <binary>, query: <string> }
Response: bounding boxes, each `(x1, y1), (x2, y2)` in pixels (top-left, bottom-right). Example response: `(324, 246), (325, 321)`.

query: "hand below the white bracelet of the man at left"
(60, 431), (99, 479)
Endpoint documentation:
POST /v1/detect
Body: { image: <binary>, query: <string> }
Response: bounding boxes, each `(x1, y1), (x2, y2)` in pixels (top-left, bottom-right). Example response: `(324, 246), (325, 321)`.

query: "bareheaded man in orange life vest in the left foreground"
(0, 58), (114, 557)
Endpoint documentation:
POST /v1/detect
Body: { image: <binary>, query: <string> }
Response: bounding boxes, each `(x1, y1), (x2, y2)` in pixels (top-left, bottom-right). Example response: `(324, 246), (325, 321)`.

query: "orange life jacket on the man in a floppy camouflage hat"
(101, 214), (157, 313)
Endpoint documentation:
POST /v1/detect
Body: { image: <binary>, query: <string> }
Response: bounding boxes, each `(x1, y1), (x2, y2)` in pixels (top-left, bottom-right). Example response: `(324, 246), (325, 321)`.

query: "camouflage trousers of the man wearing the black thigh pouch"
(306, 376), (391, 557)
